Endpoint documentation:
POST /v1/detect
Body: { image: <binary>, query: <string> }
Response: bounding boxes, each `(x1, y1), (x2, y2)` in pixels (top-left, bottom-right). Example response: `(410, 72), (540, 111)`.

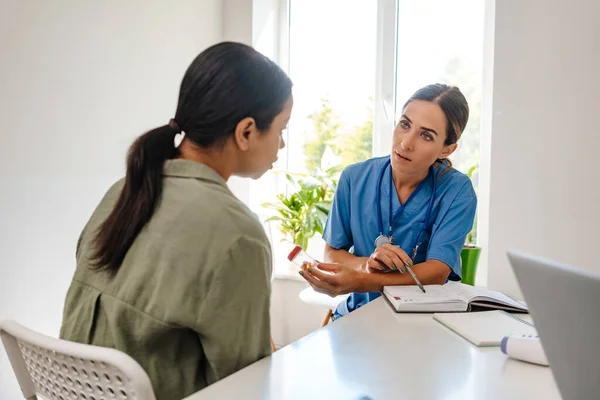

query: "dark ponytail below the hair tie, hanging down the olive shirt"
(93, 120), (181, 272)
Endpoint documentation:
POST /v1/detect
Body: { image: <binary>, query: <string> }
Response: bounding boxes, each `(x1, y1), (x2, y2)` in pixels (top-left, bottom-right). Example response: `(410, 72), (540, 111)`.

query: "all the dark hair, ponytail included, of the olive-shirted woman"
(92, 42), (292, 272)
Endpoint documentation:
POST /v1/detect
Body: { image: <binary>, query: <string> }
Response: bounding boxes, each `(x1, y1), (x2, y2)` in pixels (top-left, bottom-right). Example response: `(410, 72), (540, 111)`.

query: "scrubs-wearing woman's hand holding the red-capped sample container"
(300, 263), (370, 297)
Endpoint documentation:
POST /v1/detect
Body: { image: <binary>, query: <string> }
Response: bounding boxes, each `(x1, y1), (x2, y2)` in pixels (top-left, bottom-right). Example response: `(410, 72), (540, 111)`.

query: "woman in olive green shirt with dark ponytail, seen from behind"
(61, 43), (293, 400)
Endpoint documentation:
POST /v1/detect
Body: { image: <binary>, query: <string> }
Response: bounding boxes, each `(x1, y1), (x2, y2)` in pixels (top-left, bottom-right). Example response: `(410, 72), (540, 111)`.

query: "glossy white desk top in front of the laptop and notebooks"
(186, 298), (560, 400)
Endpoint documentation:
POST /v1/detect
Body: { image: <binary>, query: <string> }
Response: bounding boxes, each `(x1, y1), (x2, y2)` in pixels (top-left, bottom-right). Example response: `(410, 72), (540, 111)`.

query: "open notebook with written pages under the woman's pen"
(383, 282), (527, 312)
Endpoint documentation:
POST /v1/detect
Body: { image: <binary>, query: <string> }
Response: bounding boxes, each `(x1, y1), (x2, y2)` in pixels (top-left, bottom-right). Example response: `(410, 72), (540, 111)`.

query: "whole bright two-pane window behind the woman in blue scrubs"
(250, 0), (485, 272)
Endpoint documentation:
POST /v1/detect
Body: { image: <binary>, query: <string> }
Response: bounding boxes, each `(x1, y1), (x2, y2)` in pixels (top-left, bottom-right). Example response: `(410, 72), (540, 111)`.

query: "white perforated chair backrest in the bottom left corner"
(0, 320), (155, 400)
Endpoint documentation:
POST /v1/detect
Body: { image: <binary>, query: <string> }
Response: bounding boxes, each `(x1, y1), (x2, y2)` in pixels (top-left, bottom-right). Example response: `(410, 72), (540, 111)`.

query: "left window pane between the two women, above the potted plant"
(252, 0), (377, 274)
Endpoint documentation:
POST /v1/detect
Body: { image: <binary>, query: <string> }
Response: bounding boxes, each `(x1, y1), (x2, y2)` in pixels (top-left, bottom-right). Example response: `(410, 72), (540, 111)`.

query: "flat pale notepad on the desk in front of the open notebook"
(433, 310), (537, 347)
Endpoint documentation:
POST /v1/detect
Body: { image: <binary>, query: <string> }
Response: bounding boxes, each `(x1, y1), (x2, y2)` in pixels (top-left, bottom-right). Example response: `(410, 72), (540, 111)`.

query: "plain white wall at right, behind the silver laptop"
(487, 0), (600, 296)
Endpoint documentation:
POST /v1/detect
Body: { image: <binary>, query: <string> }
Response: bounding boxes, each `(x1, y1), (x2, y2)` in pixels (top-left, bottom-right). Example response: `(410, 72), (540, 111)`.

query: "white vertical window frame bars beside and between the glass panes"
(264, 0), (496, 286)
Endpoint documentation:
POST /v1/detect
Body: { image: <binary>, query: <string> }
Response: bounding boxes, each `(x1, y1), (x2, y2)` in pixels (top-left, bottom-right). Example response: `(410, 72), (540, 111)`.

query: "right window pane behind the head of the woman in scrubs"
(396, 0), (484, 178)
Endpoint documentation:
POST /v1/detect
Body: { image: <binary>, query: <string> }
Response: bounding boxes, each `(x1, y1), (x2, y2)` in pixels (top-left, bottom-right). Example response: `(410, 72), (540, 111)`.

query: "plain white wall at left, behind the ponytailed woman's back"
(0, 0), (223, 399)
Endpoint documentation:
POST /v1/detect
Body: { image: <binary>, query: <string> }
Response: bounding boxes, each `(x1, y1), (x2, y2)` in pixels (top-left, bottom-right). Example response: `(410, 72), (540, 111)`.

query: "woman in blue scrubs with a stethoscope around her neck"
(300, 84), (477, 317)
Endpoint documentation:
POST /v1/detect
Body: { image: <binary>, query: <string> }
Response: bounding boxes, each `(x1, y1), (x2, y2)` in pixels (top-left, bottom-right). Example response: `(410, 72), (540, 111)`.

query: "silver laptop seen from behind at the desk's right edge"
(508, 251), (600, 400)
